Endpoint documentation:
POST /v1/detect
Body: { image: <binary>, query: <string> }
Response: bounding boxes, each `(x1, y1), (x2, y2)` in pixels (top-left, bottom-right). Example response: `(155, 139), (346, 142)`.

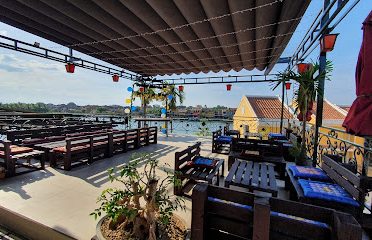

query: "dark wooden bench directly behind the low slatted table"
(228, 138), (286, 179)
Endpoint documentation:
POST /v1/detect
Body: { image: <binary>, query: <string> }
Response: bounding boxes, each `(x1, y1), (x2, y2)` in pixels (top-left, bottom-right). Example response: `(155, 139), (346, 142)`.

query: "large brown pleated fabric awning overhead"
(0, 0), (310, 76)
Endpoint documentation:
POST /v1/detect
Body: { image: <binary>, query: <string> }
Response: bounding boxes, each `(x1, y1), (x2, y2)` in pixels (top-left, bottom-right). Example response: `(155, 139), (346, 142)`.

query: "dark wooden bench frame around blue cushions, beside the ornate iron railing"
(286, 155), (371, 219)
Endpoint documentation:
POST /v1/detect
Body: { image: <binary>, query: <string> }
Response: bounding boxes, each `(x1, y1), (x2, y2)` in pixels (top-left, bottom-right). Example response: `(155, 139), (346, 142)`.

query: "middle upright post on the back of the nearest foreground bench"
(252, 198), (270, 240)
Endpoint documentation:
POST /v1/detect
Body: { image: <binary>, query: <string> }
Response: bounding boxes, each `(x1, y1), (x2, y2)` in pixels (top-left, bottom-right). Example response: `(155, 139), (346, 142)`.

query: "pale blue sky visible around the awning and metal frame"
(0, 0), (372, 107)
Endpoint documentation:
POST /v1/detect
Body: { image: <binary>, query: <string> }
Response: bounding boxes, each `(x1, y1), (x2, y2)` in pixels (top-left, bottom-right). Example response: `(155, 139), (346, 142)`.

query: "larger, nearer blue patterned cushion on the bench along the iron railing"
(298, 179), (359, 207)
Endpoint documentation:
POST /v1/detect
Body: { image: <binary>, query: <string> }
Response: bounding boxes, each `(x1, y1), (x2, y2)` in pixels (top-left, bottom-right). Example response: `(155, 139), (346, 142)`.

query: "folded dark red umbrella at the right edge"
(342, 11), (372, 136)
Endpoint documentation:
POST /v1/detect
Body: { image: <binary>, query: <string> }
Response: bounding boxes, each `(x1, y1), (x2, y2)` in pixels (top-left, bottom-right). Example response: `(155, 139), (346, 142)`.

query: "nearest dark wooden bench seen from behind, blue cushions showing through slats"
(191, 183), (362, 240)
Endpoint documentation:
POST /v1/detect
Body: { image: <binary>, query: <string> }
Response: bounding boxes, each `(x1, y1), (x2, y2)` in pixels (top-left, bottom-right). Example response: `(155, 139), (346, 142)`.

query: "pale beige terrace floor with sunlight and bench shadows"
(0, 135), (232, 239)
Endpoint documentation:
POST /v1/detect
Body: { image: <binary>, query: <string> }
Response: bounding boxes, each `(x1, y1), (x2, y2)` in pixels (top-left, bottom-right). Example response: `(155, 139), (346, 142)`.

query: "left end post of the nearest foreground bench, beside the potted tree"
(191, 183), (208, 240)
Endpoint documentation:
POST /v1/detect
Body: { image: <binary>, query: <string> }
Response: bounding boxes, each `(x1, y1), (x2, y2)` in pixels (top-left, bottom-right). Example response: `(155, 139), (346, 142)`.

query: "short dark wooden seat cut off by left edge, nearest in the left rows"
(0, 140), (45, 177)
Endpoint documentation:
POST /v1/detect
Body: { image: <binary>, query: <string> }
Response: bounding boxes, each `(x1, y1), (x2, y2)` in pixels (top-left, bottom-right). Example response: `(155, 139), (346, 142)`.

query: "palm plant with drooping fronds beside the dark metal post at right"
(274, 61), (333, 165)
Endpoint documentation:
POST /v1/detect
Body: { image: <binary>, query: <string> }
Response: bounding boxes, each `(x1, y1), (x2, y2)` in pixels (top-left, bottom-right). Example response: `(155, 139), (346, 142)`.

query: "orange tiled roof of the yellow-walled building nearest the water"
(246, 96), (292, 119)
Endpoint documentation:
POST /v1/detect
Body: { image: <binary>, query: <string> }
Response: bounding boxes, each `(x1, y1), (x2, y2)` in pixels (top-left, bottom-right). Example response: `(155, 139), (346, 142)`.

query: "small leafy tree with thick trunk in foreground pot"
(91, 154), (186, 240)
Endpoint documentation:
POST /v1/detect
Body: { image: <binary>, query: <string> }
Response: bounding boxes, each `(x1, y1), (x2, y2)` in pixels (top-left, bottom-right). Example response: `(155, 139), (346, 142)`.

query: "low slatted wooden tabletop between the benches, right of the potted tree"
(225, 159), (278, 197)
